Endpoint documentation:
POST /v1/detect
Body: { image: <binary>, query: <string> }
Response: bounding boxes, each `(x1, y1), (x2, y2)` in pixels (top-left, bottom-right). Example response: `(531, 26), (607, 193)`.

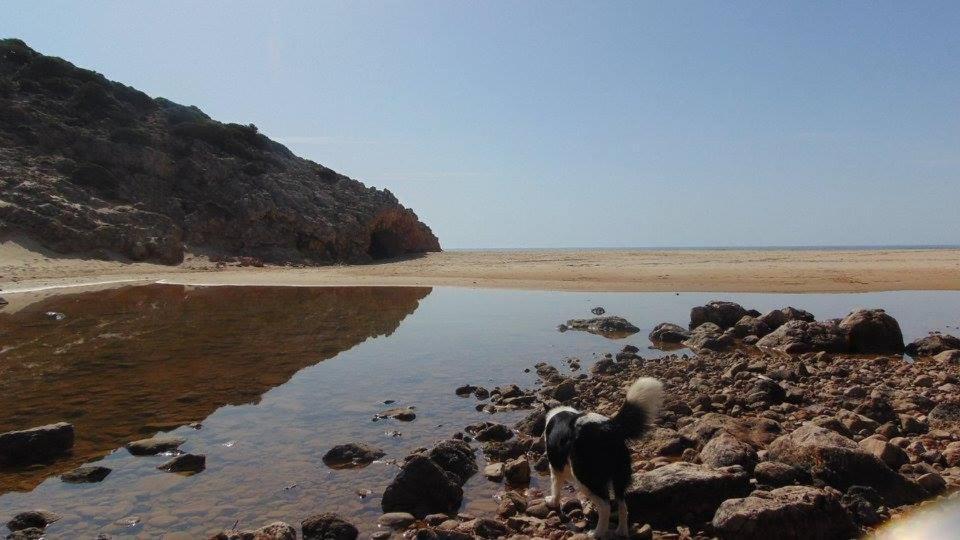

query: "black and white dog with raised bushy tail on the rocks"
(543, 377), (663, 538)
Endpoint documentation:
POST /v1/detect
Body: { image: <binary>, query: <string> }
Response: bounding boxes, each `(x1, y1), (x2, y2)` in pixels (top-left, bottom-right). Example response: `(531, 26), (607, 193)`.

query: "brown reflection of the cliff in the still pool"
(0, 285), (431, 493)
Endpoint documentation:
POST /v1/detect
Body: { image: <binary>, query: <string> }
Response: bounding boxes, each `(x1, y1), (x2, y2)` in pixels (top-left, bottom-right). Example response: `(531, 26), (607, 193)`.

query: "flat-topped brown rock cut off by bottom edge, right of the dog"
(712, 486), (859, 540)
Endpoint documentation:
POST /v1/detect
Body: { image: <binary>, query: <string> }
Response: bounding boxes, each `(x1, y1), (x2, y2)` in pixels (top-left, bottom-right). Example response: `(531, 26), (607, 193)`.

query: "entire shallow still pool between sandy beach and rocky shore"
(0, 285), (960, 538)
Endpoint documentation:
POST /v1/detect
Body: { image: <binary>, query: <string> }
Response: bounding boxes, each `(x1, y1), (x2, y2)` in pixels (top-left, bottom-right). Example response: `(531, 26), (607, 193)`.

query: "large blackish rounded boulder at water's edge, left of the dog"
(381, 454), (463, 518)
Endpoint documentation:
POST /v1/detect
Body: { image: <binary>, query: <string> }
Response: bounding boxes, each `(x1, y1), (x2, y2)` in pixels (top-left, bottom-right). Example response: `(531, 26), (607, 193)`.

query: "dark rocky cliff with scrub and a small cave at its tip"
(0, 39), (440, 264)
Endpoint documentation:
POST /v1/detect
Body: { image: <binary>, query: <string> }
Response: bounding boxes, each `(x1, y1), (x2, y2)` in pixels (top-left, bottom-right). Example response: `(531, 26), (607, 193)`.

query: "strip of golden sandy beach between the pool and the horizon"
(0, 240), (960, 293)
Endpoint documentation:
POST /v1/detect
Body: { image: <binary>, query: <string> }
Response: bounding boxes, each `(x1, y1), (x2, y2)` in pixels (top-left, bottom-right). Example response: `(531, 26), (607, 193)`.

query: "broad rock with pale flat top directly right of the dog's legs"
(626, 462), (750, 527)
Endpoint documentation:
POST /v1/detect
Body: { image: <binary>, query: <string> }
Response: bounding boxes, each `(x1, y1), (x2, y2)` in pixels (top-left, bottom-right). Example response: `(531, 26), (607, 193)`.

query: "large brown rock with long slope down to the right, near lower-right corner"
(767, 424), (925, 506)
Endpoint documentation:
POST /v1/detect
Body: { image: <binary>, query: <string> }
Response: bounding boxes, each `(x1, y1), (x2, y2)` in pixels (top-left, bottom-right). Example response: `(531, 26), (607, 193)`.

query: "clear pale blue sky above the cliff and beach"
(0, 0), (960, 248)
